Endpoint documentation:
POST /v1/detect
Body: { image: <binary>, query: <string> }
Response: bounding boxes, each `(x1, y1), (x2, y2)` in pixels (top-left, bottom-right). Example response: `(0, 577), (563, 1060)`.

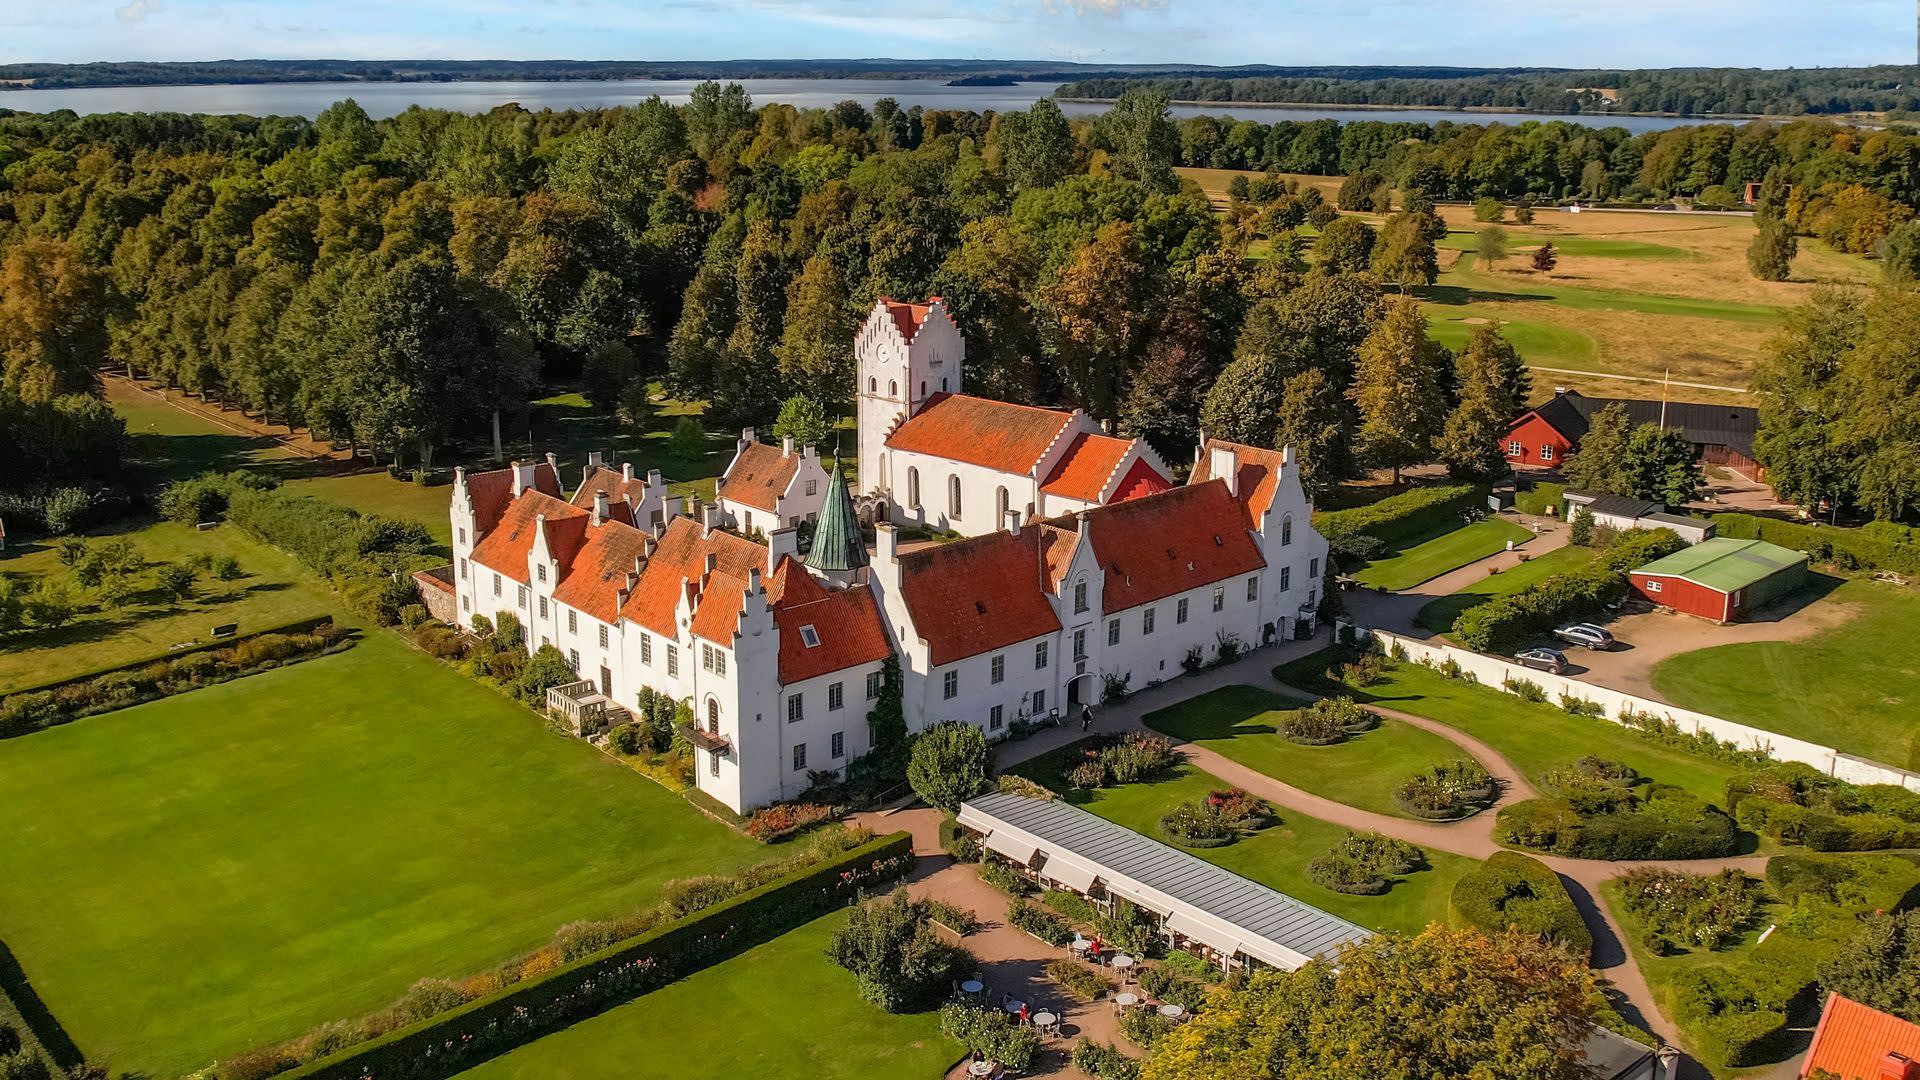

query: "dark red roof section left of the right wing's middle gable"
(900, 527), (1066, 665)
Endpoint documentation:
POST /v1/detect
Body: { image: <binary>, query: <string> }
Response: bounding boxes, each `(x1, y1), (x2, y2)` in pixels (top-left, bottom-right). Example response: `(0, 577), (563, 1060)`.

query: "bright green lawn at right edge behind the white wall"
(1653, 580), (1920, 769)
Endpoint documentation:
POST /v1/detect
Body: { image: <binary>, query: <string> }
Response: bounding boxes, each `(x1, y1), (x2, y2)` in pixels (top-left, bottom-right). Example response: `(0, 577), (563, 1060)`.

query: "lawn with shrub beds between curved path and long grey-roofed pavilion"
(1016, 748), (1476, 932)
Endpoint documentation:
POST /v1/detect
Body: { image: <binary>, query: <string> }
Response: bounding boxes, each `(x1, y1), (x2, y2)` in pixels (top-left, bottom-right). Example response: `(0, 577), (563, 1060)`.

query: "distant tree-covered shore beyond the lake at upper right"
(1056, 63), (1920, 117)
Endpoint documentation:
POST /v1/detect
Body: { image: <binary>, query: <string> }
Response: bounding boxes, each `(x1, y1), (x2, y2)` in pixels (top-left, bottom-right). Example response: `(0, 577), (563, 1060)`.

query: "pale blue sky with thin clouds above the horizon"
(0, 0), (1916, 67)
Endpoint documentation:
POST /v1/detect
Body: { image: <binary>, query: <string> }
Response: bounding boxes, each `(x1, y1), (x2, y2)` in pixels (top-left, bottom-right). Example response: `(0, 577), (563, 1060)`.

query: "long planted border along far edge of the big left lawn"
(0, 617), (353, 738)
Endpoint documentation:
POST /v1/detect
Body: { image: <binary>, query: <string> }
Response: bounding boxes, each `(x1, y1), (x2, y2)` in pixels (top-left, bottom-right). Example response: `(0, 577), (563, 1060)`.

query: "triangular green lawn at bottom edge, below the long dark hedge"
(461, 913), (962, 1080)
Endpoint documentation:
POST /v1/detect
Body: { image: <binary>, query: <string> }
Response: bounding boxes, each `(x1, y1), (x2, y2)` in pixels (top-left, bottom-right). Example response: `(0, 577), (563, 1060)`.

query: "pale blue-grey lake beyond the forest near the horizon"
(0, 79), (1703, 131)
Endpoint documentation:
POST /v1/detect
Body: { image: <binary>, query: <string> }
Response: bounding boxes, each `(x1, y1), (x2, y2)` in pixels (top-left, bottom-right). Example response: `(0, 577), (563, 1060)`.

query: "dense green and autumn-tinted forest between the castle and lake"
(0, 83), (1920, 528)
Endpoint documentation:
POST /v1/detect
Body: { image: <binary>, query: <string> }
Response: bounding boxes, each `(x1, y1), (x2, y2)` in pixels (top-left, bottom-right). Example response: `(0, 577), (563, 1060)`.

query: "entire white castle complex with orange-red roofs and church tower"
(451, 298), (1327, 811)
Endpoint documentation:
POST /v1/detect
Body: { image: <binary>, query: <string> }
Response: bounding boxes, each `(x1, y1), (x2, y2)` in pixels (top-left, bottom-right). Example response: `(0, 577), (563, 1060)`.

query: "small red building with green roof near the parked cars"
(1628, 538), (1807, 623)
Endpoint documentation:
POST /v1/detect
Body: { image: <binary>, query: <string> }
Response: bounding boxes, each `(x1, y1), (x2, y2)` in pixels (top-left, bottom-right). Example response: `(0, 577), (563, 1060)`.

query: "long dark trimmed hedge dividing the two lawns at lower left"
(264, 832), (914, 1080)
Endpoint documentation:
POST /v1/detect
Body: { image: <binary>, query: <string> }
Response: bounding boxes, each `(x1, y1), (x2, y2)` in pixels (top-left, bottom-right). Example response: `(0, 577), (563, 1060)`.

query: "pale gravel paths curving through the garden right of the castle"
(995, 640), (1793, 1076)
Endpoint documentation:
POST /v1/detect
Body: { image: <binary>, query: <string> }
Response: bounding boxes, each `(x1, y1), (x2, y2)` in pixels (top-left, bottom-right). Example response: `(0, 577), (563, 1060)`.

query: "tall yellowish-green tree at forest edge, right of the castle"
(1348, 296), (1448, 484)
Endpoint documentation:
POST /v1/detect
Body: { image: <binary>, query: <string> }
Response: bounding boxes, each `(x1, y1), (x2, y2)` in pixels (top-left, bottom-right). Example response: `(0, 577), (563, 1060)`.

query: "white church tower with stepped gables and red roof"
(852, 296), (966, 492)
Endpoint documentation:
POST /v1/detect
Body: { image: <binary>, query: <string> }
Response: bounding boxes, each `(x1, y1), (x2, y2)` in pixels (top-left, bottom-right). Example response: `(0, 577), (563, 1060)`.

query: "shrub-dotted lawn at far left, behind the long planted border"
(0, 521), (332, 694)
